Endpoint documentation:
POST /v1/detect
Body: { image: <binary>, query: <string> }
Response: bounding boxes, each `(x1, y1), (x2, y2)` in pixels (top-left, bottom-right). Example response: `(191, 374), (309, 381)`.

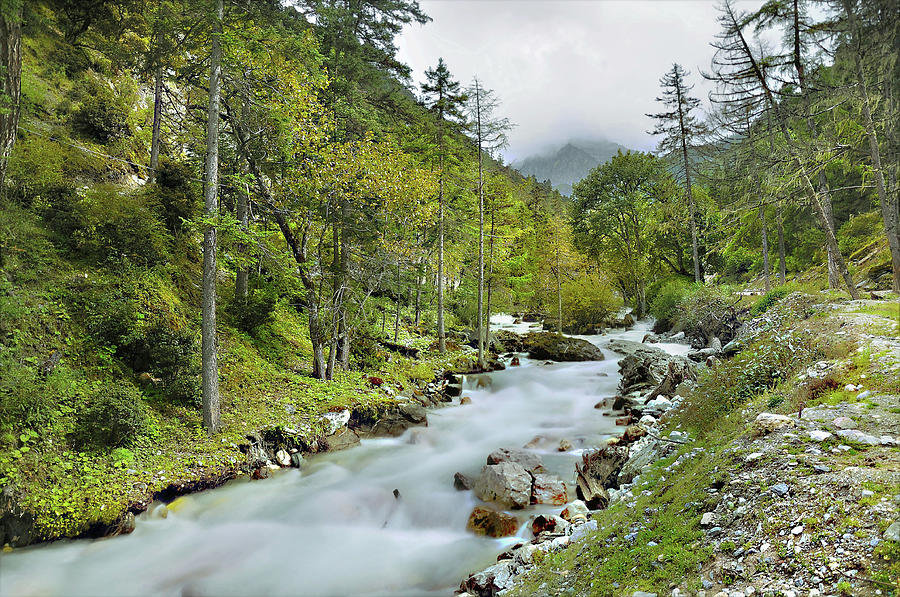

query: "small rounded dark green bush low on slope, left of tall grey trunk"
(76, 385), (148, 448)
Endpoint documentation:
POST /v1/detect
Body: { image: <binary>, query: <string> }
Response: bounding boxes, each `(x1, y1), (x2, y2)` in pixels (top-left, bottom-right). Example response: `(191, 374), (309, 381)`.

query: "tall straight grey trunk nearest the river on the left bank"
(201, 0), (224, 433)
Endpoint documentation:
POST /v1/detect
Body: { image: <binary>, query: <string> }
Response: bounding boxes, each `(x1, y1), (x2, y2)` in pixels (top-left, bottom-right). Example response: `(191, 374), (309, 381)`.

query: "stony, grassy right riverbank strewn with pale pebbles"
(508, 295), (900, 597)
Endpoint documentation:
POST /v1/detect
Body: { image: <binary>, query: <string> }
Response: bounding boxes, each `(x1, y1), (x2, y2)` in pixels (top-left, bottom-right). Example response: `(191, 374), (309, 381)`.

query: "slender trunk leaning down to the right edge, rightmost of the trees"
(842, 0), (900, 292)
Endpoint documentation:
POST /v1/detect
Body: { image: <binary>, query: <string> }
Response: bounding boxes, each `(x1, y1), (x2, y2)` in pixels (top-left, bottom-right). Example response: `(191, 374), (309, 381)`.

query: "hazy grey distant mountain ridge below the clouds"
(512, 139), (628, 196)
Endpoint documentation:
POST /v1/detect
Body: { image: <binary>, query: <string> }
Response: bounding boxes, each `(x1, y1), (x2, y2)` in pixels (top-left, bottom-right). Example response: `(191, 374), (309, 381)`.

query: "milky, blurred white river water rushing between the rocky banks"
(0, 316), (686, 596)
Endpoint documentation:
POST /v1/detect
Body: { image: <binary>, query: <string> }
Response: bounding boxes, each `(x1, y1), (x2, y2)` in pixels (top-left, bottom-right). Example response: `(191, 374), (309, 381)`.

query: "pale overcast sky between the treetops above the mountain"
(399, 0), (760, 161)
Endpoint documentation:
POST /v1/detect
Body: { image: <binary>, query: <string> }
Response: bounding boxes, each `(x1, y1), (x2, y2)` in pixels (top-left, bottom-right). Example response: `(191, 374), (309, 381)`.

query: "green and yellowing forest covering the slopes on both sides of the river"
(0, 0), (900, 594)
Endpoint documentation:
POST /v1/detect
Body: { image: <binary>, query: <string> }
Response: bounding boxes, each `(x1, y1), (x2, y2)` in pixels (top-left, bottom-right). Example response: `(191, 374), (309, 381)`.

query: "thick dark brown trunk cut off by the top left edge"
(0, 1), (22, 194)
